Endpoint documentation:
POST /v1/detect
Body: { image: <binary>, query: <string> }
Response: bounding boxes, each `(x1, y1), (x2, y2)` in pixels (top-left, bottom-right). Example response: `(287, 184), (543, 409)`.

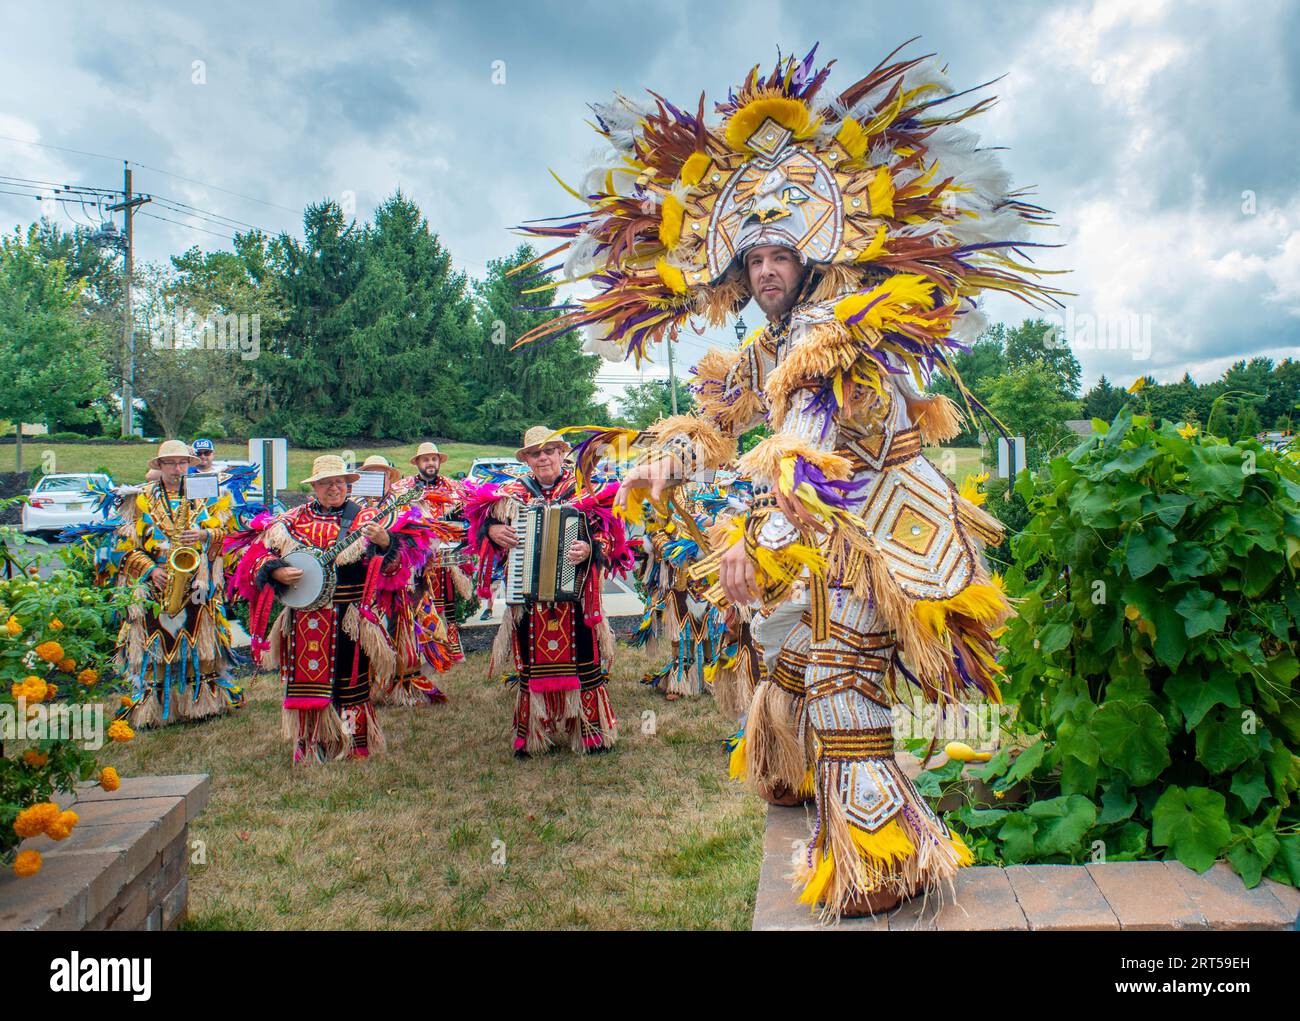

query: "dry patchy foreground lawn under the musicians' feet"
(100, 646), (764, 929)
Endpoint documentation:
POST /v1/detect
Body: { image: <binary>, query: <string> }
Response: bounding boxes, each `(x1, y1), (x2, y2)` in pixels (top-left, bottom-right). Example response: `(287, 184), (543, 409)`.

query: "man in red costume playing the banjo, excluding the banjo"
(228, 454), (428, 762)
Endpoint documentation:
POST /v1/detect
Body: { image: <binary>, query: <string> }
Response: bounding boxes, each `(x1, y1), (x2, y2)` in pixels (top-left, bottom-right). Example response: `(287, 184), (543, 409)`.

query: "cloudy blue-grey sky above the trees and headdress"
(0, 0), (1300, 403)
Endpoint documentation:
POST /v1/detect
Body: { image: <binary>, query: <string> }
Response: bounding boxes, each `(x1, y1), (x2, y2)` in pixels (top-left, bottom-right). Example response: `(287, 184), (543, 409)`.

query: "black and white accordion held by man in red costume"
(506, 503), (590, 605)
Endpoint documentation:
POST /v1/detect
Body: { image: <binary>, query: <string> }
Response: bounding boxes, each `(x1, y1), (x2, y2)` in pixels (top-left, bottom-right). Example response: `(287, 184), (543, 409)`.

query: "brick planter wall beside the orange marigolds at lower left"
(0, 774), (211, 931)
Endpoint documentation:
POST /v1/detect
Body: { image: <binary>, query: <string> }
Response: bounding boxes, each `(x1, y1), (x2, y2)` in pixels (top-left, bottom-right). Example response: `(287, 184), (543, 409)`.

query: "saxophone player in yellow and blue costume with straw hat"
(111, 440), (243, 727)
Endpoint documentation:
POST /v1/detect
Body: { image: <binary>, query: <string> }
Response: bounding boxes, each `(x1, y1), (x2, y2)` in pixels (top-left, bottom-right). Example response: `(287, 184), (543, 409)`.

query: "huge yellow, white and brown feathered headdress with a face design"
(519, 43), (1063, 362)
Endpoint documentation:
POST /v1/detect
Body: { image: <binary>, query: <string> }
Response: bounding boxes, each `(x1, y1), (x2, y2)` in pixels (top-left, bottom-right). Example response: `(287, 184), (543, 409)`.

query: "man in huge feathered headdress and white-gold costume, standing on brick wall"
(512, 41), (1054, 916)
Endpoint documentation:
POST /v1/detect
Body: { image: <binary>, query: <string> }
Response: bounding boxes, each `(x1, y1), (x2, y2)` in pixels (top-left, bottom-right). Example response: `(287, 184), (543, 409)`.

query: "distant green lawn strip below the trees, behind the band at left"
(0, 437), (515, 489)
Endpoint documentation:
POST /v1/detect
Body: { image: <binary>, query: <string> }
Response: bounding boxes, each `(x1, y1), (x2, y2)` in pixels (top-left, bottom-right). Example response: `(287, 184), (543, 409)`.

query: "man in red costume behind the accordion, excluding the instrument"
(465, 425), (631, 758)
